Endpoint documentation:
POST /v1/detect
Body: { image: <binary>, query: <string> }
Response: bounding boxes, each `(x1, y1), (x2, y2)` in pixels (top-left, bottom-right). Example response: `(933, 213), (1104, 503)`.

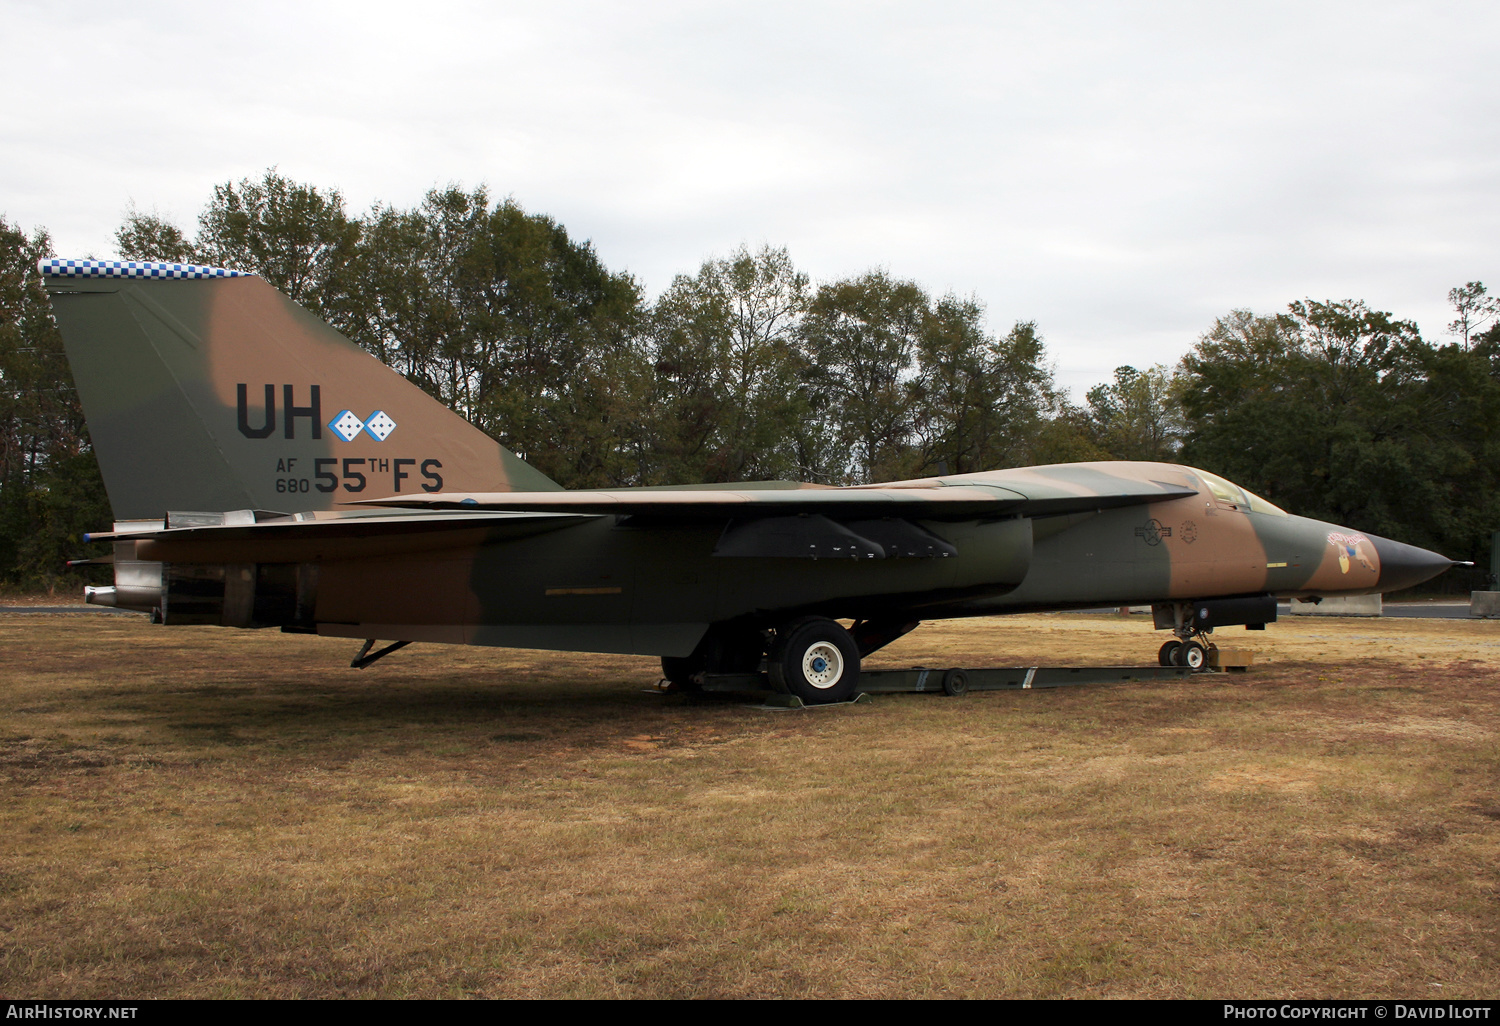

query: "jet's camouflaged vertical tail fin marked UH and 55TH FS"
(42, 260), (560, 521)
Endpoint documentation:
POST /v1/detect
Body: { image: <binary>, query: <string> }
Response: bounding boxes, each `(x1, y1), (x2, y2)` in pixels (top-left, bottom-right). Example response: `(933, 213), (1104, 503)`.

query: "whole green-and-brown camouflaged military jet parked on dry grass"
(42, 260), (1452, 702)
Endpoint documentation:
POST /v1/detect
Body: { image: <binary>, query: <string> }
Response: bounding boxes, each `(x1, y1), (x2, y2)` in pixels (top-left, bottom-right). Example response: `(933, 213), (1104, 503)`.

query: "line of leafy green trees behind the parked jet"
(0, 170), (1500, 585)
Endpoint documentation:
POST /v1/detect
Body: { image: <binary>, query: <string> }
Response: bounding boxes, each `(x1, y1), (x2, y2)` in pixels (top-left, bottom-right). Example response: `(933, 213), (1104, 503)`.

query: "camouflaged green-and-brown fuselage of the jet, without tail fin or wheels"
(117, 464), (1416, 656)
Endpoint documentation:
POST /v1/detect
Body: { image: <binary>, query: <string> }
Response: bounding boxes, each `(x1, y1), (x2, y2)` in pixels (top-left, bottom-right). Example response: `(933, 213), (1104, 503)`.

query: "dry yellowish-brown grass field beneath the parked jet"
(0, 614), (1500, 998)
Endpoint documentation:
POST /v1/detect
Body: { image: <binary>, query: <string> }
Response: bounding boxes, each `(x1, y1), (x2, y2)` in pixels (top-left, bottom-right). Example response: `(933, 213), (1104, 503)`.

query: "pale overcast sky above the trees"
(0, 0), (1500, 393)
